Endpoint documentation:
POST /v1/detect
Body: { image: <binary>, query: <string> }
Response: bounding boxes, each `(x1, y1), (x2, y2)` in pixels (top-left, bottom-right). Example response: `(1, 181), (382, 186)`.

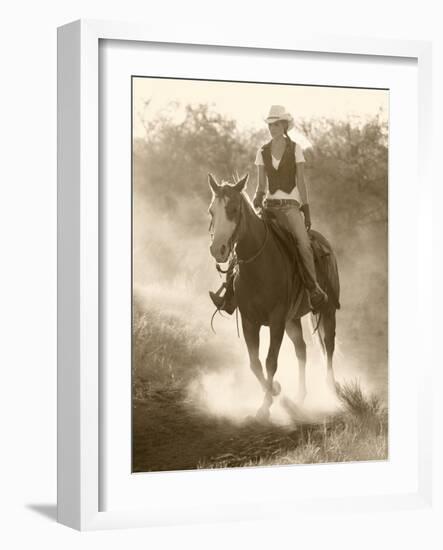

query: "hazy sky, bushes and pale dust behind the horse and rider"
(133, 78), (388, 474)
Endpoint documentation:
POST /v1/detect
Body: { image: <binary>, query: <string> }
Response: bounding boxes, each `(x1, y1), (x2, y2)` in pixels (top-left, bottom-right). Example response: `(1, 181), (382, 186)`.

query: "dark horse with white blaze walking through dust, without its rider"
(208, 174), (339, 418)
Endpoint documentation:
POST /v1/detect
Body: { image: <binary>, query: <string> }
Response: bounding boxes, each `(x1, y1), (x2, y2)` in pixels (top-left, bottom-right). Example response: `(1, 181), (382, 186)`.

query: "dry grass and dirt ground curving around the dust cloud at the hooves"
(133, 299), (388, 471)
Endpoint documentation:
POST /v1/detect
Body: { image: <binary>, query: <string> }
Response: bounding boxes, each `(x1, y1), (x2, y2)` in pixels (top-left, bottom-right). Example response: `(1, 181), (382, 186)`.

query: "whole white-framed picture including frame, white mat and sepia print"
(58, 21), (434, 530)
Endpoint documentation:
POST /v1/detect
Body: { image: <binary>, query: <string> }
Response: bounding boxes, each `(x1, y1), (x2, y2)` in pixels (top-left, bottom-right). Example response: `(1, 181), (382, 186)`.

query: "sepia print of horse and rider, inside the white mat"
(130, 75), (389, 473)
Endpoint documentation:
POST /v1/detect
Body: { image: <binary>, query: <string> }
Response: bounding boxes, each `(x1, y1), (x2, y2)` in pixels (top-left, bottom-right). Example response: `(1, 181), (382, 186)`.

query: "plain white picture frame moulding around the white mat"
(57, 20), (433, 530)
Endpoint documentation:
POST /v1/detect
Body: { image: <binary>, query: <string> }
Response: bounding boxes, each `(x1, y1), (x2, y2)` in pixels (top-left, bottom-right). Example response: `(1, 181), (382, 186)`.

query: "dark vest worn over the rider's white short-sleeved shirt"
(261, 137), (297, 193)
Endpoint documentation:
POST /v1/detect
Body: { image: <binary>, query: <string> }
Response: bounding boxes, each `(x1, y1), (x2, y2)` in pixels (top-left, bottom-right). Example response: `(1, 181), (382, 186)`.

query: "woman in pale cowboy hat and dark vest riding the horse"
(209, 105), (327, 314)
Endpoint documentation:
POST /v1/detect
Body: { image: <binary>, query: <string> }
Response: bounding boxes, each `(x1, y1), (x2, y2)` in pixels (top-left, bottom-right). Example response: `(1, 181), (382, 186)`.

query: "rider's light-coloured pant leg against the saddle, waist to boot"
(266, 205), (318, 290)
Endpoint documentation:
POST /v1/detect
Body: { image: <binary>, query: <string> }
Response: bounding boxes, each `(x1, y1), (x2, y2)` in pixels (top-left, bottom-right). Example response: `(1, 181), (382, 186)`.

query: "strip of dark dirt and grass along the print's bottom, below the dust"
(132, 389), (387, 472)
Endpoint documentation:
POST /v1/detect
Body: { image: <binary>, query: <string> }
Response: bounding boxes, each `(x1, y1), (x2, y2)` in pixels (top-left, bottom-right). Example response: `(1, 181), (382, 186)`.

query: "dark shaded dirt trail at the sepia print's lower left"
(133, 390), (320, 472)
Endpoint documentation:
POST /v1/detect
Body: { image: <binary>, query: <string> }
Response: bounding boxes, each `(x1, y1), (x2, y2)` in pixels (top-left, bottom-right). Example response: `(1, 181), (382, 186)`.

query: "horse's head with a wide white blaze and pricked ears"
(208, 174), (249, 263)
